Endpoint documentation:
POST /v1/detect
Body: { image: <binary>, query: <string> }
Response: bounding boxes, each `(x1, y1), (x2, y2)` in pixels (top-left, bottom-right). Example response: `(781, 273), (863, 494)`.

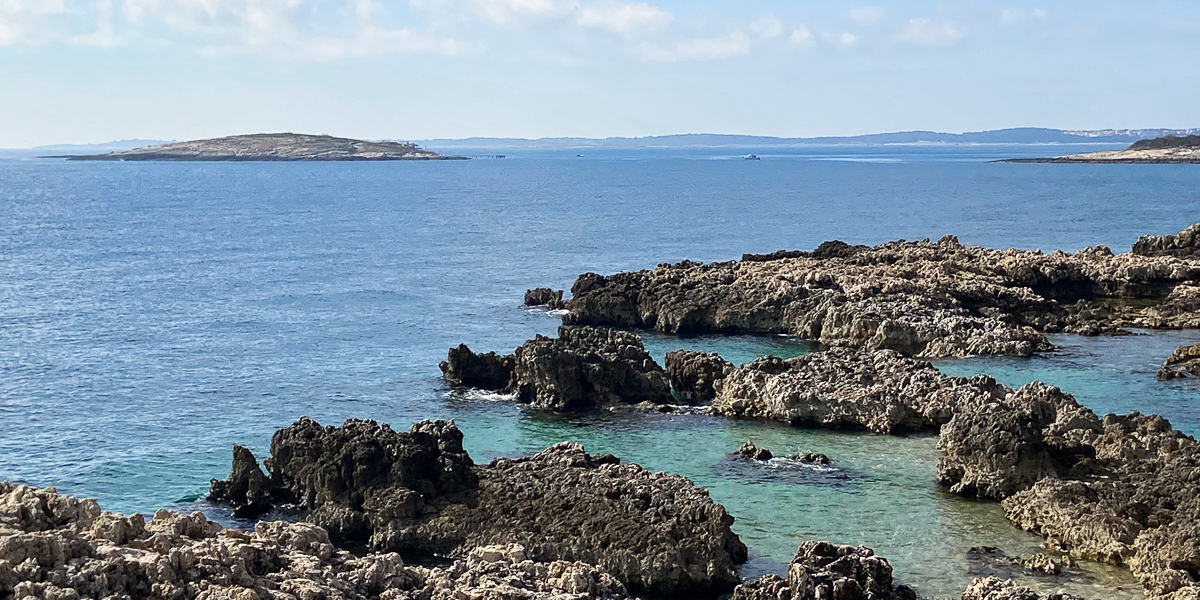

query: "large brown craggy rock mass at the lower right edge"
(937, 383), (1200, 599)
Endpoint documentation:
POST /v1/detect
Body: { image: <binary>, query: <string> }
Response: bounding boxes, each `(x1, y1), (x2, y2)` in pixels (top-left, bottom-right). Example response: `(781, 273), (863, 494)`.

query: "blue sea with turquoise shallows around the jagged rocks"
(0, 146), (1200, 598)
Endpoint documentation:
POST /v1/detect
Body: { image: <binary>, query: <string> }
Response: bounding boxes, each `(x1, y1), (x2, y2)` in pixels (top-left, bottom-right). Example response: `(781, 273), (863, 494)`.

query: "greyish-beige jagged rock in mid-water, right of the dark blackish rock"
(712, 348), (1007, 433)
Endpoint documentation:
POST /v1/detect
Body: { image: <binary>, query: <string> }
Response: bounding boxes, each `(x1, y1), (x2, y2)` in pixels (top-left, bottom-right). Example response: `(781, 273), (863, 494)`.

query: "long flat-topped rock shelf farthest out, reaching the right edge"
(564, 229), (1200, 356)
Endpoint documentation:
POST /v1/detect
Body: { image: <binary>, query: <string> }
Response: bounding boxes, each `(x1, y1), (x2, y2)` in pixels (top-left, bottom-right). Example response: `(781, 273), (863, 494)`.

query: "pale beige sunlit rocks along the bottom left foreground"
(0, 484), (630, 600)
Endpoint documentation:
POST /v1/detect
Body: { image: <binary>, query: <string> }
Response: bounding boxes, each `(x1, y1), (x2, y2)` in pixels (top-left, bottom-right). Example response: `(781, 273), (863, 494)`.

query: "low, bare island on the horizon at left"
(66, 133), (466, 161)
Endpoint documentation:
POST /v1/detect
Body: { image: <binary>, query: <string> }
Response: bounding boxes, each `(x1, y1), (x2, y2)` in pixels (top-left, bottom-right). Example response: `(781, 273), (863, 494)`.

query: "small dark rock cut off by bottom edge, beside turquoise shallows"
(733, 541), (917, 600)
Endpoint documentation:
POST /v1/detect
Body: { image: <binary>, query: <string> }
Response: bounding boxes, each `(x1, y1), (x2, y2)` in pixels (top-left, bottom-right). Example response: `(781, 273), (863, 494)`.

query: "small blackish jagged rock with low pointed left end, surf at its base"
(440, 326), (674, 410)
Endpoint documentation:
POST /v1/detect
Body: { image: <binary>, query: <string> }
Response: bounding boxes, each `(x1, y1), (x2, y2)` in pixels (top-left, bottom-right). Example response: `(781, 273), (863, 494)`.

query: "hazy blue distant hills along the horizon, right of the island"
(418, 127), (1200, 149)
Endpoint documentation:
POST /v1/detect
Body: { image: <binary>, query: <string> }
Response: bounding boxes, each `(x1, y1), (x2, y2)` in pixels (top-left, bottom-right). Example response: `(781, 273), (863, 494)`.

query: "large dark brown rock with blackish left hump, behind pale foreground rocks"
(212, 419), (746, 598)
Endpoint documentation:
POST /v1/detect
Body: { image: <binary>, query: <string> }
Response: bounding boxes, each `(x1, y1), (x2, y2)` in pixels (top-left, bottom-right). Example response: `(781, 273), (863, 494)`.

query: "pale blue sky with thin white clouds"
(0, 0), (1200, 148)
